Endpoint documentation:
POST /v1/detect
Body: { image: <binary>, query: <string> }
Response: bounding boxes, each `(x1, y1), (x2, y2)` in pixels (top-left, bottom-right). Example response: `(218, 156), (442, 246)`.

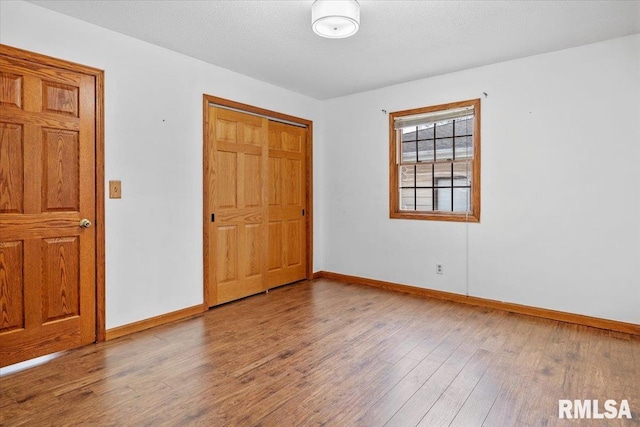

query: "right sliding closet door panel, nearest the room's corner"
(268, 122), (307, 288)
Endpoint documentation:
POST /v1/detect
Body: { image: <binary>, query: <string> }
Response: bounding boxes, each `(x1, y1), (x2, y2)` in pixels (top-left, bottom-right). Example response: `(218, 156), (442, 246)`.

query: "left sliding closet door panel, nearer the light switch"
(208, 107), (268, 306)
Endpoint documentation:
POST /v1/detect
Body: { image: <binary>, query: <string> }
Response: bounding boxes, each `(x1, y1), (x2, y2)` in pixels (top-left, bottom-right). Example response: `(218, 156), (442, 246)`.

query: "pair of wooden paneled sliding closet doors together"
(204, 101), (310, 306)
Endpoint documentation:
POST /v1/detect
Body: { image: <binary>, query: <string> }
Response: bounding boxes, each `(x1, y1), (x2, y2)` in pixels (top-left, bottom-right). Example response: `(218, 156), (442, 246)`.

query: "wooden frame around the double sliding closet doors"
(202, 94), (313, 310)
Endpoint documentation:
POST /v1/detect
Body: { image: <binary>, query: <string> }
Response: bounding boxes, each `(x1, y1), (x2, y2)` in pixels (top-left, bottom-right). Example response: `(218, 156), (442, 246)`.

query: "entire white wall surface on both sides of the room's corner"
(0, 1), (640, 328)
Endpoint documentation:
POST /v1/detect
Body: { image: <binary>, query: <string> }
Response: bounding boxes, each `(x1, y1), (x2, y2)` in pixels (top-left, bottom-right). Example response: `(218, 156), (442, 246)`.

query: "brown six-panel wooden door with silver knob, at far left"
(0, 52), (96, 366)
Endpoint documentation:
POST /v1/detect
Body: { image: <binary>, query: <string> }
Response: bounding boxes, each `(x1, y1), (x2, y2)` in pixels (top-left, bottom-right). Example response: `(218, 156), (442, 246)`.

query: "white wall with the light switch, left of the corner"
(0, 1), (322, 328)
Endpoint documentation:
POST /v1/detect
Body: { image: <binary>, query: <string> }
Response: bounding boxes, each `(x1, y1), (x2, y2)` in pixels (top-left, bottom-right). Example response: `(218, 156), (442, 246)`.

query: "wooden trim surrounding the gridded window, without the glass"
(389, 99), (481, 222)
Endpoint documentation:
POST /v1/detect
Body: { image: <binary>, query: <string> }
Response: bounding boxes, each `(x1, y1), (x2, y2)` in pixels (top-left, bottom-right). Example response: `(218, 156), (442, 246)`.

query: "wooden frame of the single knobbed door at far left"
(0, 44), (106, 342)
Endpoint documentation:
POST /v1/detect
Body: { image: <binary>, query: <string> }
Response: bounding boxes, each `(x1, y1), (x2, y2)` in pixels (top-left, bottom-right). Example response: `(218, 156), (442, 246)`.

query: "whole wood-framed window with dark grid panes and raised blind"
(389, 99), (480, 222)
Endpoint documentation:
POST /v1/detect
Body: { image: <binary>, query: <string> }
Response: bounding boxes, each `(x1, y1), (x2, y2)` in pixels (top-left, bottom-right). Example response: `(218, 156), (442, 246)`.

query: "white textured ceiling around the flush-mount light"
(25, 0), (640, 99)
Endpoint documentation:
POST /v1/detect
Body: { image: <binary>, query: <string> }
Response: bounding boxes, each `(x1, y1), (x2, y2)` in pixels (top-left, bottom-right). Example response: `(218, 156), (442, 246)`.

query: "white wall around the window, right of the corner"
(316, 35), (640, 323)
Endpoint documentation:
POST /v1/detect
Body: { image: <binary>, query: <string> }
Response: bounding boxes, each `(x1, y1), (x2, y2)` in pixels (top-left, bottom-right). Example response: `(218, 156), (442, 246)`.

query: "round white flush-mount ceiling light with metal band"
(311, 0), (360, 39)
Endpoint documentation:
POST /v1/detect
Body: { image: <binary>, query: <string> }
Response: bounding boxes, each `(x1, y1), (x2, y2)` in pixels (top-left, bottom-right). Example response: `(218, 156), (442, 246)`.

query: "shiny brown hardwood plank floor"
(0, 279), (640, 427)
